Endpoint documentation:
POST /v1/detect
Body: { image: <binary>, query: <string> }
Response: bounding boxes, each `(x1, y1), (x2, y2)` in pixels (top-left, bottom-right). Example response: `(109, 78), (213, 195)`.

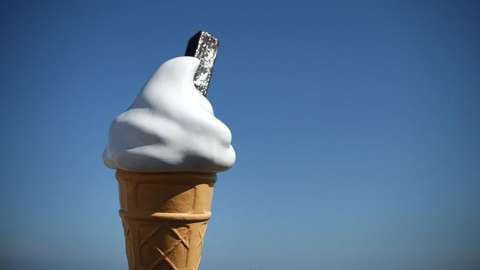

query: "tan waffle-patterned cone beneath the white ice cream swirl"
(116, 170), (216, 270)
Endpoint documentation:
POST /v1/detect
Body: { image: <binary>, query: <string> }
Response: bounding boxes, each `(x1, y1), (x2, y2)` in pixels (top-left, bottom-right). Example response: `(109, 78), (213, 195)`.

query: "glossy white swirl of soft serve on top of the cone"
(103, 56), (235, 172)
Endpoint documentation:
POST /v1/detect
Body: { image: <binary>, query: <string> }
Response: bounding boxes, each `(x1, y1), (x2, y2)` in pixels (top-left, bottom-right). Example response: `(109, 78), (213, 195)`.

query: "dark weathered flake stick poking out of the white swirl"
(185, 31), (219, 96)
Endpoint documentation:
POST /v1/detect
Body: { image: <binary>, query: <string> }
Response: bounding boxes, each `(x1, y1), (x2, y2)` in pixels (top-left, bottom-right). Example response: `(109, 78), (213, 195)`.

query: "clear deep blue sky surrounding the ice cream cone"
(0, 1), (480, 270)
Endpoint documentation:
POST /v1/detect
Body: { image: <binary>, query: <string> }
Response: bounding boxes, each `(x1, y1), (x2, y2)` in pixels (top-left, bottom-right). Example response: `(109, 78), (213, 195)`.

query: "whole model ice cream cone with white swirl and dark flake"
(103, 32), (235, 270)
